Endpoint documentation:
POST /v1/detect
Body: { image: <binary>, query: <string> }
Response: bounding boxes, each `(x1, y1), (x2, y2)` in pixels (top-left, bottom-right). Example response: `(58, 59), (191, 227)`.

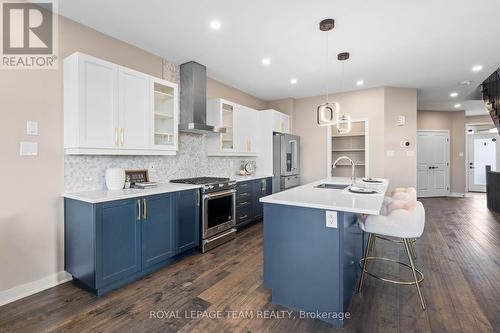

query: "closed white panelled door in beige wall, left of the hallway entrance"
(417, 131), (450, 197)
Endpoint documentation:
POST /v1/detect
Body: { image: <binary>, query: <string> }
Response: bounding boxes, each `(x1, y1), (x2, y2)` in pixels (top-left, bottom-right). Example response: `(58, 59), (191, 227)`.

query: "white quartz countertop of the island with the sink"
(260, 177), (389, 215)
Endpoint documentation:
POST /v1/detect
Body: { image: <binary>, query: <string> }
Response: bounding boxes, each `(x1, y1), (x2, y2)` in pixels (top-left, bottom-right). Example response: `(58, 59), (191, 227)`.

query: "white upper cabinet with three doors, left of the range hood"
(64, 52), (178, 155)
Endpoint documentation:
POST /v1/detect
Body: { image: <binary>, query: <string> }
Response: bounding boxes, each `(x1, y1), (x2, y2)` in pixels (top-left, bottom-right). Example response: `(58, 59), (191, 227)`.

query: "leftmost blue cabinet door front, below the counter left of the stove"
(95, 199), (141, 288)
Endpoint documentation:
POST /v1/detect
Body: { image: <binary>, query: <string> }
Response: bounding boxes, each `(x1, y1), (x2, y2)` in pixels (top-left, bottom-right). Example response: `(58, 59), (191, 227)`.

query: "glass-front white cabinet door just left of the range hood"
(152, 79), (179, 150)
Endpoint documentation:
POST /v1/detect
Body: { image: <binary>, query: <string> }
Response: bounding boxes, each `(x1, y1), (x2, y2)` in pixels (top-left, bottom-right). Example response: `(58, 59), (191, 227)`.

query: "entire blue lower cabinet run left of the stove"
(64, 190), (199, 295)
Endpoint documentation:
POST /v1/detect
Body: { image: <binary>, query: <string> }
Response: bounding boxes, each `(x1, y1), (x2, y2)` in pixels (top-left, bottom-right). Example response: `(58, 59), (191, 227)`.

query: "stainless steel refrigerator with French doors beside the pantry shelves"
(273, 132), (300, 193)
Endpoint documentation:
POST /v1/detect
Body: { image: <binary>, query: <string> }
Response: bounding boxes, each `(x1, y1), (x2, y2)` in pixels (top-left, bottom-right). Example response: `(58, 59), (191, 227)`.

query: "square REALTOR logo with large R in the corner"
(1, 0), (57, 69)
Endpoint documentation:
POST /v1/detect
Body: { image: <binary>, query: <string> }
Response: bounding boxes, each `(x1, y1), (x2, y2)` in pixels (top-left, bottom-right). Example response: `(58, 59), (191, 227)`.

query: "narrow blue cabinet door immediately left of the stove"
(177, 190), (201, 253)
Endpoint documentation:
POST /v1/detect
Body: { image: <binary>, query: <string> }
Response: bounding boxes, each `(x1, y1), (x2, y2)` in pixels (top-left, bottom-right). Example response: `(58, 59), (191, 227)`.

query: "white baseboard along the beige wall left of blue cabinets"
(0, 271), (73, 306)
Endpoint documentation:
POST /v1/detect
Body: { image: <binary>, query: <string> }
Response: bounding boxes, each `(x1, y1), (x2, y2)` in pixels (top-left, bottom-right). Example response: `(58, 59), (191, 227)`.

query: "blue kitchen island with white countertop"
(260, 177), (388, 327)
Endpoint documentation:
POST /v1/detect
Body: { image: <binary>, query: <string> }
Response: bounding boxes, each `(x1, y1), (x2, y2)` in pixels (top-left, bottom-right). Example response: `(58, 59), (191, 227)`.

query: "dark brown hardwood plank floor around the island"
(0, 195), (500, 332)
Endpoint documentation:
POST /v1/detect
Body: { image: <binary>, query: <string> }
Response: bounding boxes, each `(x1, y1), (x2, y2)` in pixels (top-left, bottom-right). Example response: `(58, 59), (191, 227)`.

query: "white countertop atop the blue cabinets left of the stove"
(63, 183), (200, 204)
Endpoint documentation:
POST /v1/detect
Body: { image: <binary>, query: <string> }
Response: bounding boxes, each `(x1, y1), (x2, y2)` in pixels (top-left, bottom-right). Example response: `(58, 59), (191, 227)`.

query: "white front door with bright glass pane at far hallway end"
(467, 134), (498, 192)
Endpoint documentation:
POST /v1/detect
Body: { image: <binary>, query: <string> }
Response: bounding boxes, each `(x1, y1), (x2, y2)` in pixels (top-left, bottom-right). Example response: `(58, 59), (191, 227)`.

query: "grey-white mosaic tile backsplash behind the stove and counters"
(64, 133), (252, 192)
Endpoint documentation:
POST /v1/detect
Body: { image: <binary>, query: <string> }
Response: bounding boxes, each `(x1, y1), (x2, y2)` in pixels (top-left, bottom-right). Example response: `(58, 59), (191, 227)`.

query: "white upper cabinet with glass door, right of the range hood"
(207, 98), (259, 156)
